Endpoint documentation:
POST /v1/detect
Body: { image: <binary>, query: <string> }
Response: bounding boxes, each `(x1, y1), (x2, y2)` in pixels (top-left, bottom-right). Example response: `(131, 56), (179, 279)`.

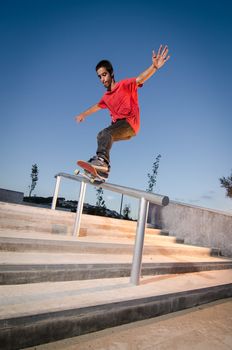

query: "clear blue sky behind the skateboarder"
(0, 0), (232, 216)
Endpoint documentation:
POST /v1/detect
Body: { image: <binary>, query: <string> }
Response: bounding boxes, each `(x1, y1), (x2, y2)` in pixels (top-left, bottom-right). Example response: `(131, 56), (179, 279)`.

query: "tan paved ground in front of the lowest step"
(25, 298), (232, 350)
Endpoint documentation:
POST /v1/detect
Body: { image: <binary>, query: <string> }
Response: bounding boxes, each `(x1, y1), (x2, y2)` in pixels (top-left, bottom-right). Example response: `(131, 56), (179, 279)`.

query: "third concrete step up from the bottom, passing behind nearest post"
(0, 235), (219, 256)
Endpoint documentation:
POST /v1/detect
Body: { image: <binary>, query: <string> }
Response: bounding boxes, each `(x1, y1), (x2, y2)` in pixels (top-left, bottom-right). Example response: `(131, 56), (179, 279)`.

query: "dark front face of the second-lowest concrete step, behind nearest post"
(0, 261), (232, 285)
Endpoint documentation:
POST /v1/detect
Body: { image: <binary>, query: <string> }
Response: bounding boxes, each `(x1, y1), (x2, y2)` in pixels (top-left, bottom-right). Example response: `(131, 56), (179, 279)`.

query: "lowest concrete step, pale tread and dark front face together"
(0, 270), (232, 350)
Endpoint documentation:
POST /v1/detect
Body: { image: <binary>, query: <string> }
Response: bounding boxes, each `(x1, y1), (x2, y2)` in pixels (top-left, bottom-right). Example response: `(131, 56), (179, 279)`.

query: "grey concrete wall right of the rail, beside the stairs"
(148, 201), (232, 257)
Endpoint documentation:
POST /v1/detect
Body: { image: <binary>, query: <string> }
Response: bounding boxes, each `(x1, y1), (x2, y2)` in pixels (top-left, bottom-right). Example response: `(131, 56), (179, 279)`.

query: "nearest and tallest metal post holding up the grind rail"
(130, 197), (149, 286)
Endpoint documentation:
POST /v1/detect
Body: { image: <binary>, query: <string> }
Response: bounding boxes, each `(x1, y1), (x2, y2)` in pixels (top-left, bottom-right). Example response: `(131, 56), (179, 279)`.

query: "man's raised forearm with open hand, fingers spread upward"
(136, 45), (170, 85)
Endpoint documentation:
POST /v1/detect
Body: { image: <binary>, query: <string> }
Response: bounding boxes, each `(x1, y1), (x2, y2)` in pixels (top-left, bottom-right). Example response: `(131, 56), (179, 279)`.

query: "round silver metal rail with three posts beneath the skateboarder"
(52, 173), (169, 285)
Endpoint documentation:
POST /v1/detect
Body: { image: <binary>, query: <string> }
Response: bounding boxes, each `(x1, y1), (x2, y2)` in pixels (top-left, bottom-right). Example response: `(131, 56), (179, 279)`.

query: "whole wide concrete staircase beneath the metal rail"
(0, 202), (232, 349)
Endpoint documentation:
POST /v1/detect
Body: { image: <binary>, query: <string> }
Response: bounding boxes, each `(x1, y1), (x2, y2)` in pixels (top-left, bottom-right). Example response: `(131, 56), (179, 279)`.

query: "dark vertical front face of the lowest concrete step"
(0, 283), (232, 350)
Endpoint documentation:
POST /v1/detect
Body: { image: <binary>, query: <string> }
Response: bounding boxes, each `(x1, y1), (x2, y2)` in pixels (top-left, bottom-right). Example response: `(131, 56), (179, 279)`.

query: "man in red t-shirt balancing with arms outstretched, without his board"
(75, 45), (170, 178)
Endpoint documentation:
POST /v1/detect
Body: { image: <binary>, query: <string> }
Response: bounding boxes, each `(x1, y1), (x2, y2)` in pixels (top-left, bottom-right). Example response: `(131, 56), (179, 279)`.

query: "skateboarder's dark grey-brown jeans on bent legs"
(96, 119), (135, 163)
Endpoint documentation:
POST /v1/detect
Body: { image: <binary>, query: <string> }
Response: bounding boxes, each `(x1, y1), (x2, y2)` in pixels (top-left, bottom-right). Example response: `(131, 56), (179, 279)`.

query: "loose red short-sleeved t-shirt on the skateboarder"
(98, 78), (142, 134)
